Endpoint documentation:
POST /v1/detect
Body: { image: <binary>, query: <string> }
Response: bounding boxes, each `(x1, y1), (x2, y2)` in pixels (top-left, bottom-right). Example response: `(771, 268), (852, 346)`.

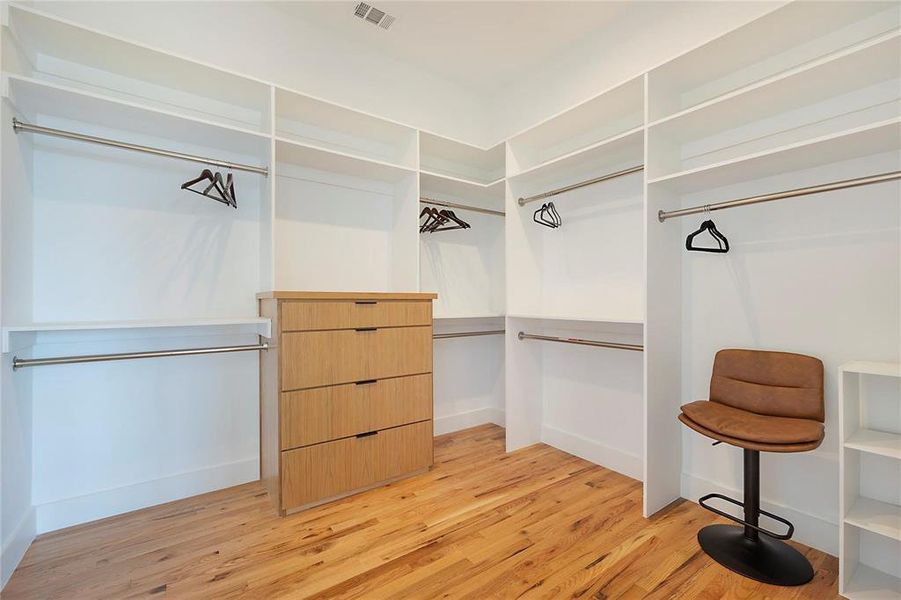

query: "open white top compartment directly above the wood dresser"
(275, 88), (417, 169)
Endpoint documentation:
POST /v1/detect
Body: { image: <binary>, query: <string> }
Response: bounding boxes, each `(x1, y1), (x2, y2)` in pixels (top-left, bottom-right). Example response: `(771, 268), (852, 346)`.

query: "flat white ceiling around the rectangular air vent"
(272, 0), (636, 93)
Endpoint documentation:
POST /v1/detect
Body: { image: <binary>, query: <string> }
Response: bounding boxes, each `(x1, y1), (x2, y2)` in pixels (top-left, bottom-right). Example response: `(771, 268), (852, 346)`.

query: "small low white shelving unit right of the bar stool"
(838, 361), (901, 600)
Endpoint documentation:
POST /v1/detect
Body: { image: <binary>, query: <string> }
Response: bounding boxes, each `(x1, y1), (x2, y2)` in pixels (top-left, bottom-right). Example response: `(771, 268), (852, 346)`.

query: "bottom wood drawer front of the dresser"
(282, 421), (432, 510)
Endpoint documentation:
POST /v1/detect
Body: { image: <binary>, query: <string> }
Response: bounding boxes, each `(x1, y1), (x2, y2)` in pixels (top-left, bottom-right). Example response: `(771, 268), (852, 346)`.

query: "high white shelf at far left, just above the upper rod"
(3, 75), (270, 161)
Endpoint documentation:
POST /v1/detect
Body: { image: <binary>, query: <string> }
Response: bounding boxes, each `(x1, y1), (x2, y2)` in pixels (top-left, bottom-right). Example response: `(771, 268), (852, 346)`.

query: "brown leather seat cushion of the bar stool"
(680, 400), (825, 451)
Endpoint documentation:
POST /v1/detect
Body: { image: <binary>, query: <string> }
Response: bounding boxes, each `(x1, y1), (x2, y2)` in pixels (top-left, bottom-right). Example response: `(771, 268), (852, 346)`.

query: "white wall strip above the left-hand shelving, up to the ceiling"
(33, 2), (488, 143)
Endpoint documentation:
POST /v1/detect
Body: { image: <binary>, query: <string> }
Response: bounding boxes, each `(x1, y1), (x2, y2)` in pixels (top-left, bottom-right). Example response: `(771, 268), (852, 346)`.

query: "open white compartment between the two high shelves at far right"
(648, 31), (901, 179)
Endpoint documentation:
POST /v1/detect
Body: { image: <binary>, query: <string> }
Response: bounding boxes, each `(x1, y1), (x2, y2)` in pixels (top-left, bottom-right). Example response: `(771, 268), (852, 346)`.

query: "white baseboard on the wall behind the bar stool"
(682, 473), (838, 556)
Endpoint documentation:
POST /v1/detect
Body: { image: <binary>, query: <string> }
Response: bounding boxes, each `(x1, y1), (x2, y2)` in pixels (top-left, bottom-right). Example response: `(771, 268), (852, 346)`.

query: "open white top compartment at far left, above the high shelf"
(2, 5), (270, 133)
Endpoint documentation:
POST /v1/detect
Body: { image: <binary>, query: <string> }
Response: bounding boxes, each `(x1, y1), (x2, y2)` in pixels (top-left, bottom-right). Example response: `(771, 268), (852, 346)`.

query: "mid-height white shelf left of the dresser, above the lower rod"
(2, 317), (272, 352)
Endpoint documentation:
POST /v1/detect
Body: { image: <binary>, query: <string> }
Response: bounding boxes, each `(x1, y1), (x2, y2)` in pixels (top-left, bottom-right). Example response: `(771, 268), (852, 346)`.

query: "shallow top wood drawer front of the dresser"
(281, 300), (432, 331)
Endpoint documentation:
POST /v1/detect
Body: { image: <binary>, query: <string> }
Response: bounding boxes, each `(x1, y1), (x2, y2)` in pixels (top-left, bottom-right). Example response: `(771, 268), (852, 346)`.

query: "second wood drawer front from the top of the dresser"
(281, 326), (432, 391)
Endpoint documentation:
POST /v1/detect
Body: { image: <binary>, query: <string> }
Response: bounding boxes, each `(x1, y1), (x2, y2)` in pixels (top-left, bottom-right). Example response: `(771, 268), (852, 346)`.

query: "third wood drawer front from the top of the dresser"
(281, 374), (432, 450)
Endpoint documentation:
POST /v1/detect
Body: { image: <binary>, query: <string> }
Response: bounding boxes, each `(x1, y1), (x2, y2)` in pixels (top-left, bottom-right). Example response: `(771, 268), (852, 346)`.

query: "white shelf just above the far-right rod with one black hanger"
(648, 118), (901, 193)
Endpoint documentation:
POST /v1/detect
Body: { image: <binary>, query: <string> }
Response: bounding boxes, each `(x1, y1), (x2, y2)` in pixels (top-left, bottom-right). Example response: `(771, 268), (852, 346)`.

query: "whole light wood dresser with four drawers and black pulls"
(257, 292), (437, 515)
